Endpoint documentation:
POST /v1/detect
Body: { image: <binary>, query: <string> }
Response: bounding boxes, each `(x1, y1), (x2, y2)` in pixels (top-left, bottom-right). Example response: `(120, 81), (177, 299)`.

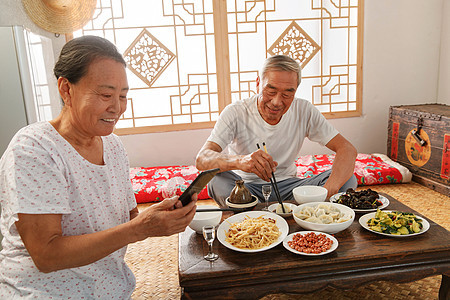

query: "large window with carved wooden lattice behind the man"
(74, 0), (364, 134)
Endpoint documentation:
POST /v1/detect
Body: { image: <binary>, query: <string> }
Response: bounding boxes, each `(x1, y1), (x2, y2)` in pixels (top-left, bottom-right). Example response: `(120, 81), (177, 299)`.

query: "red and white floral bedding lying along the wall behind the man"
(130, 154), (404, 203)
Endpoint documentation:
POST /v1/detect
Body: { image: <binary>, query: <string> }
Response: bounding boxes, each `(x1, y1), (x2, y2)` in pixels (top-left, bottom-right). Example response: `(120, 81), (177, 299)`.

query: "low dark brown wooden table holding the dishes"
(179, 194), (450, 299)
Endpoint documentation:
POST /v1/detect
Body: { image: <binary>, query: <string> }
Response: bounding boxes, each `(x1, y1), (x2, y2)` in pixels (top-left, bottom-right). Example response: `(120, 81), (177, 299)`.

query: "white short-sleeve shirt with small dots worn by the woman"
(0, 122), (136, 299)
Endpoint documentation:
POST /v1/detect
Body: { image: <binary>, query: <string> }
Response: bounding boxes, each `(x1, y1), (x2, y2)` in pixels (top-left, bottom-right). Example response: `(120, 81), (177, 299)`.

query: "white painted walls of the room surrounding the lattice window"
(0, 0), (450, 166)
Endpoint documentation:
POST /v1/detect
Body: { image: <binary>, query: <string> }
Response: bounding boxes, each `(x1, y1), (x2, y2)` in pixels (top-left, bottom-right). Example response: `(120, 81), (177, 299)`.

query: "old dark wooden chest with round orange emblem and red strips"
(387, 104), (450, 196)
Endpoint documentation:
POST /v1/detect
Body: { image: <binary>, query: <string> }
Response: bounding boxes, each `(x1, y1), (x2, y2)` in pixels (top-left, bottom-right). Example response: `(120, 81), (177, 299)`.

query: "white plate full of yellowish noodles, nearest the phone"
(217, 211), (289, 252)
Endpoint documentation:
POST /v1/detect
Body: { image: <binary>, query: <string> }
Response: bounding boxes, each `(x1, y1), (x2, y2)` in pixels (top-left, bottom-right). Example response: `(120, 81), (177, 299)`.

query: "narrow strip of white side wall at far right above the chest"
(438, 0), (450, 105)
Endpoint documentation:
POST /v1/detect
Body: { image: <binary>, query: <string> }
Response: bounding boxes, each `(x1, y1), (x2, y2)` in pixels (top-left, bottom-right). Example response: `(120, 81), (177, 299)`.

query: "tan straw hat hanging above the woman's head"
(22, 0), (97, 33)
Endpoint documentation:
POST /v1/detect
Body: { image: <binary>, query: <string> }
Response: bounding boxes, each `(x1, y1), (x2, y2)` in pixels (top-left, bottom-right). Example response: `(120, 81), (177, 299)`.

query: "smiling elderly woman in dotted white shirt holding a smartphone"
(0, 36), (197, 299)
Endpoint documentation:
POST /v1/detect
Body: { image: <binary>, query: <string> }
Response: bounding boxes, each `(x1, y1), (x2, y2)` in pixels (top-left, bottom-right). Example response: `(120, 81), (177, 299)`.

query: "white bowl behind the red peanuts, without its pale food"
(292, 202), (355, 233)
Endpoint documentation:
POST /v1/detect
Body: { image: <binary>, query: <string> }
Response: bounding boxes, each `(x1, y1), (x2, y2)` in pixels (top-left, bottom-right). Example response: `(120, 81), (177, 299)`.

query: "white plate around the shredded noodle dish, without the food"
(217, 211), (289, 252)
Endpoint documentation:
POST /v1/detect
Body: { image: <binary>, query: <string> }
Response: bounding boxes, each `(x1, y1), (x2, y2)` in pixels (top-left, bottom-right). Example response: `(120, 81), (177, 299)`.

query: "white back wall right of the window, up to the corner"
(302, 0), (447, 154)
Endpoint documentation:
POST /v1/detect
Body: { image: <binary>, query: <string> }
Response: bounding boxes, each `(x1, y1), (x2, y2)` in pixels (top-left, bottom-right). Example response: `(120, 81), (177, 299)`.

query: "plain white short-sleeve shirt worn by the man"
(208, 95), (339, 183)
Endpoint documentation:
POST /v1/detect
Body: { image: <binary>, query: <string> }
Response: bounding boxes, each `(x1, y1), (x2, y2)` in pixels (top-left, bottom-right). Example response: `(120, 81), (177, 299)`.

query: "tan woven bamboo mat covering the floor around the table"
(125, 182), (450, 300)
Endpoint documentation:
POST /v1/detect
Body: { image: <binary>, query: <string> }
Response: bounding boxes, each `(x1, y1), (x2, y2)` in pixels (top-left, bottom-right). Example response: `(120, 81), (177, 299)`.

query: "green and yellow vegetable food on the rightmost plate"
(367, 209), (423, 235)
